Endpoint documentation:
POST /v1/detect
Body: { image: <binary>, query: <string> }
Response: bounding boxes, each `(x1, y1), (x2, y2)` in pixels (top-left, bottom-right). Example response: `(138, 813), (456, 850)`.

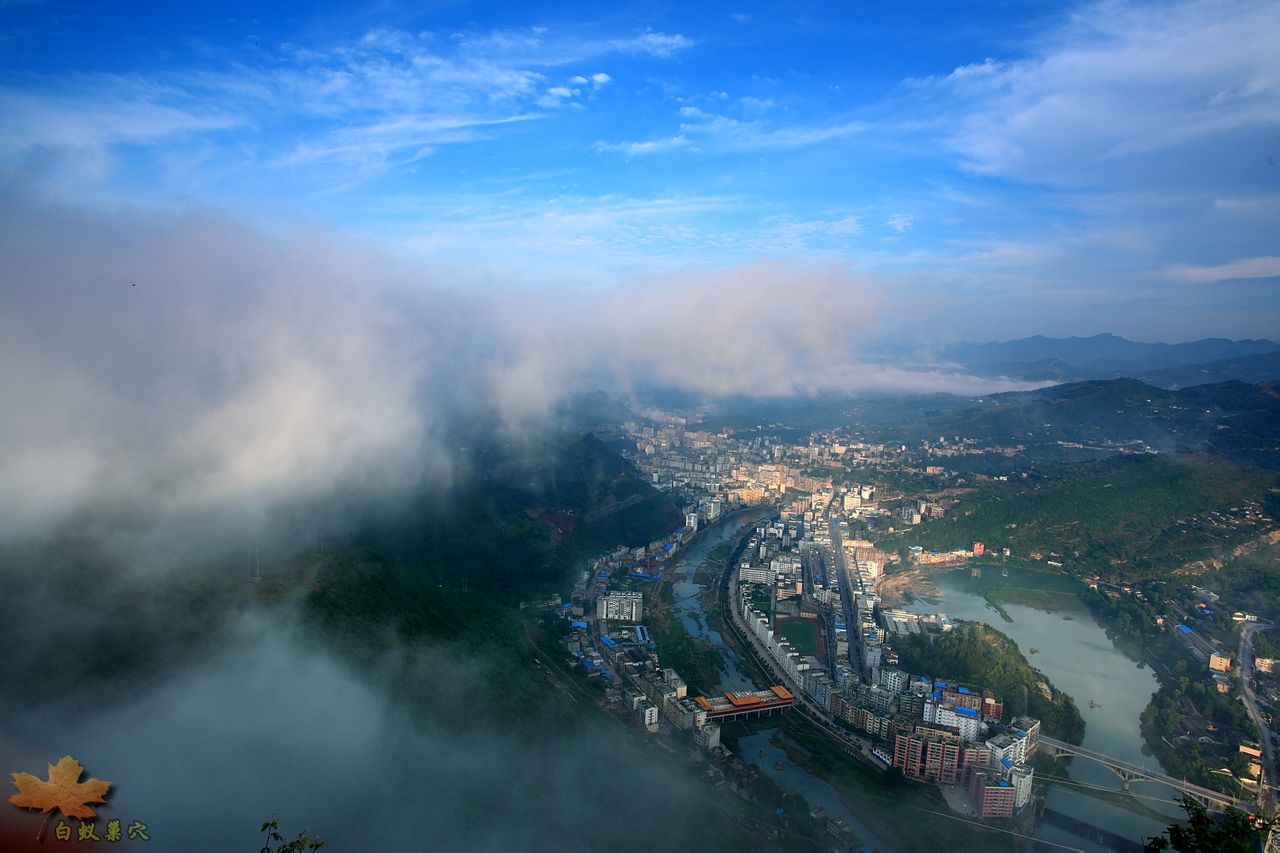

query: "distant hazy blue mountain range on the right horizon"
(941, 333), (1280, 376)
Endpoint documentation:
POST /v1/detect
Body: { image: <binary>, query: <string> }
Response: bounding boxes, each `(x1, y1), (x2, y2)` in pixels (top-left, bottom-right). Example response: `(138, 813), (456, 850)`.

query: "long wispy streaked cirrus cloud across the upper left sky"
(0, 28), (694, 192)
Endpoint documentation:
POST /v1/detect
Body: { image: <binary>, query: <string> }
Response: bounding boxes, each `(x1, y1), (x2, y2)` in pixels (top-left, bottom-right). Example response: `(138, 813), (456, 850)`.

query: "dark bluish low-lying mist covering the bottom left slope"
(0, 601), (742, 850)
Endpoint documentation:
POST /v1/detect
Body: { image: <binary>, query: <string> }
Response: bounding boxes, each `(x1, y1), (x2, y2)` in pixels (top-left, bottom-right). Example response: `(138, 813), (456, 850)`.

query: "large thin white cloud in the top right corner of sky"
(910, 0), (1280, 186)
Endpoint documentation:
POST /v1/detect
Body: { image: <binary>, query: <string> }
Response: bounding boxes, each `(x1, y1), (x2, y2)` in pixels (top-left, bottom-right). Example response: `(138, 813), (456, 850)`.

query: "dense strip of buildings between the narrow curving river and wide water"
(735, 485), (1039, 817)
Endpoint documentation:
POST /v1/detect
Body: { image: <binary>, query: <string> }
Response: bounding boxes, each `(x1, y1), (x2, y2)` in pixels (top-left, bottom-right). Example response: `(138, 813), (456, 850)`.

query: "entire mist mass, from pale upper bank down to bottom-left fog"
(0, 193), (1029, 849)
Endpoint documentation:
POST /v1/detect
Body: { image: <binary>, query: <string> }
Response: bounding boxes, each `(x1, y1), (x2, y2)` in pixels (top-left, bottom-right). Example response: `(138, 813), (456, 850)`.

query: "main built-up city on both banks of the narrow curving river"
(550, 411), (1039, 817)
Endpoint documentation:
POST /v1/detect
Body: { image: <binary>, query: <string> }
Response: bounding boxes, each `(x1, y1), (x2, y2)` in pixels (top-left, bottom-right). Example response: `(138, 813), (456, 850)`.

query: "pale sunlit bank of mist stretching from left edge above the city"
(0, 186), (1034, 539)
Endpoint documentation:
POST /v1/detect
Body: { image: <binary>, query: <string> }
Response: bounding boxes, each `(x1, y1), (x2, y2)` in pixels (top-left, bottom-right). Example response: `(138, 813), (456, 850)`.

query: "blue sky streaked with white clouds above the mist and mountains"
(0, 3), (1280, 339)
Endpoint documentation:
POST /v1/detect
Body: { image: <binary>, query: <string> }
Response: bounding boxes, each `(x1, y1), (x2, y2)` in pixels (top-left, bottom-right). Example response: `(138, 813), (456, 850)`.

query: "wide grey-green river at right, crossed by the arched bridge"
(908, 569), (1183, 850)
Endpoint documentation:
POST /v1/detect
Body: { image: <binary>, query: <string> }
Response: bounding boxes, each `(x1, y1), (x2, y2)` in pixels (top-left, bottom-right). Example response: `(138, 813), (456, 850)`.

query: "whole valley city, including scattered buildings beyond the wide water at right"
(527, 410), (1275, 841)
